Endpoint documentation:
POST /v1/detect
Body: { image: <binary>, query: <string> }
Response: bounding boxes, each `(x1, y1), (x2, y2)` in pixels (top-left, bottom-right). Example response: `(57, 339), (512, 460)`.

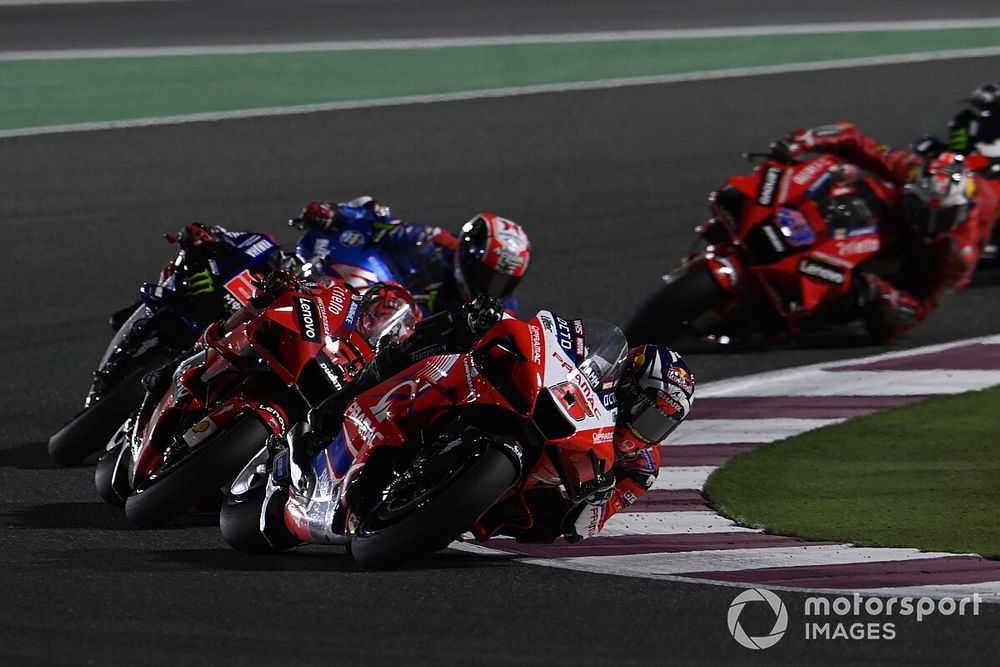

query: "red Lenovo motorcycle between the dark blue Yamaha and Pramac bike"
(95, 271), (416, 527)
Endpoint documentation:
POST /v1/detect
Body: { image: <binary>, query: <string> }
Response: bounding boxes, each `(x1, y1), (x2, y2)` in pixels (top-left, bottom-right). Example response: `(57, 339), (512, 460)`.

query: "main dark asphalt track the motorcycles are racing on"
(0, 9), (1000, 664)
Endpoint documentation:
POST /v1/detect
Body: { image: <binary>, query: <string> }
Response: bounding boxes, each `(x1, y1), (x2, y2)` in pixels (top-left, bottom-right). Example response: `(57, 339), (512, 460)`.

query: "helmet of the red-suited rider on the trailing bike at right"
(902, 152), (976, 242)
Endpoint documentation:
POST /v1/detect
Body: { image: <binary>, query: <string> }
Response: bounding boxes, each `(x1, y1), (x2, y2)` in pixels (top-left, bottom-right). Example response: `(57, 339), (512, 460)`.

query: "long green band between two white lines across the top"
(0, 28), (1000, 129)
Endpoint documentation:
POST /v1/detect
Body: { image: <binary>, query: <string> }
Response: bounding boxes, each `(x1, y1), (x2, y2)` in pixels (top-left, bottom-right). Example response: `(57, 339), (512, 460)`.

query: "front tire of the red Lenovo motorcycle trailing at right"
(624, 263), (726, 347)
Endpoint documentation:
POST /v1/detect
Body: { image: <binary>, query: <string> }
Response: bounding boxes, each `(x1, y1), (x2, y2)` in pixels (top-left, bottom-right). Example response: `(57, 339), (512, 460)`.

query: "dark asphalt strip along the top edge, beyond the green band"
(0, 0), (996, 51)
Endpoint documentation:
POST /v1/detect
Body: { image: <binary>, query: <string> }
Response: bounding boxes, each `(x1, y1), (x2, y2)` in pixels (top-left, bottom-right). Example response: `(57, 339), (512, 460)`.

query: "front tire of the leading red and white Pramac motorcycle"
(350, 448), (518, 570)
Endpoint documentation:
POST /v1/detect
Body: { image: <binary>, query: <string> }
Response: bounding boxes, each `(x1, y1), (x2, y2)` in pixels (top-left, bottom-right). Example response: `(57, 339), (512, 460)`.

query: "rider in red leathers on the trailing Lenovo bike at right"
(782, 122), (998, 340)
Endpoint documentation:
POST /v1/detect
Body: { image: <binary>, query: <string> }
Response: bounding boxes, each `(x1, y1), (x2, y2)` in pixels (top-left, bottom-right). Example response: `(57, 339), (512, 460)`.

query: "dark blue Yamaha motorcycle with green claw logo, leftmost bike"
(48, 223), (278, 465)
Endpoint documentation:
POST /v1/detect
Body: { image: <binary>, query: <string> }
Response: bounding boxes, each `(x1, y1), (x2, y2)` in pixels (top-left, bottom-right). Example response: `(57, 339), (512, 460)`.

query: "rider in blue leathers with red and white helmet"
(292, 197), (531, 315)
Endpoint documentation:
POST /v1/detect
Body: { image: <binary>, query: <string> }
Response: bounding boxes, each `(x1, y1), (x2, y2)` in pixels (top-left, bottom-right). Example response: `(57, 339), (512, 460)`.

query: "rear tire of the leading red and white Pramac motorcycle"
(219, 482), (299, 554)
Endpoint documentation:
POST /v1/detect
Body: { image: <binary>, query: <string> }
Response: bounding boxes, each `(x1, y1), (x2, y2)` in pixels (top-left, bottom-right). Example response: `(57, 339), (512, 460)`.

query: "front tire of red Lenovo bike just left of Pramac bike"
(125, 414), (271, 528)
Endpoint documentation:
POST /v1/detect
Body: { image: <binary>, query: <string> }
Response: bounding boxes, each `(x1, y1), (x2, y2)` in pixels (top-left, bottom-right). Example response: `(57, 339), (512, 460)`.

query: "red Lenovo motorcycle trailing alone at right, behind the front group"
(625, 151), (894, 345)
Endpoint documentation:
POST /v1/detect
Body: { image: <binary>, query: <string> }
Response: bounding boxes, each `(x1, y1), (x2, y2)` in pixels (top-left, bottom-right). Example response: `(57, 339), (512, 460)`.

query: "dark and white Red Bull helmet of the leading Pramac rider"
(617, 345), (694, 445)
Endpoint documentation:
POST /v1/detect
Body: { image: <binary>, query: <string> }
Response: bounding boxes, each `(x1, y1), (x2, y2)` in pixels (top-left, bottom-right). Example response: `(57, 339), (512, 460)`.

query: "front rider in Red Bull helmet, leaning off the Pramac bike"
(288, 297), (694, 542)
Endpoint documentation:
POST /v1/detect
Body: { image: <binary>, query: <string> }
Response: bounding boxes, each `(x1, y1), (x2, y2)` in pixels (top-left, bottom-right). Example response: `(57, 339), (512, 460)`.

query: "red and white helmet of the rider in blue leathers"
(454, 213), (531, 301)
